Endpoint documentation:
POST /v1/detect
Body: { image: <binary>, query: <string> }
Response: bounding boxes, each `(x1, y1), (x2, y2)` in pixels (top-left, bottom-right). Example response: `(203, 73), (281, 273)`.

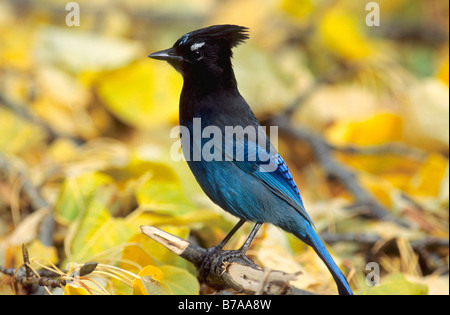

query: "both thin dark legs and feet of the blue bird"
(199, 219), (262, 279)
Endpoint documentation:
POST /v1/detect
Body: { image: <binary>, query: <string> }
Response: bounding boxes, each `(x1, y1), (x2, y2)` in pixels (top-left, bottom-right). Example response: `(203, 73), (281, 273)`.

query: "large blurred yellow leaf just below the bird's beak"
(98, 60), (181, 129)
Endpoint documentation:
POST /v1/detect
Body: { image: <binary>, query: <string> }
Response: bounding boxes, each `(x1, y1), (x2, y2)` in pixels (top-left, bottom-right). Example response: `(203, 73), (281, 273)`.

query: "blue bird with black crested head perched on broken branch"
(149, 25), (352, 295)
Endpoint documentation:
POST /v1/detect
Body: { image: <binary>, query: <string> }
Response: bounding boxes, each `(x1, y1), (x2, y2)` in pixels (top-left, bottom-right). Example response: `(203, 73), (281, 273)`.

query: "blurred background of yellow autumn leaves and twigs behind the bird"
(0, 0), (449, 294)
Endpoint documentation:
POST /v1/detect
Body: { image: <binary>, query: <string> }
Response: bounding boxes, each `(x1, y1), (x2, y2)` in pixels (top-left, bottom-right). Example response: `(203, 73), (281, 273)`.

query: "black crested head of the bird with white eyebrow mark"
(149, 25), (249, 86)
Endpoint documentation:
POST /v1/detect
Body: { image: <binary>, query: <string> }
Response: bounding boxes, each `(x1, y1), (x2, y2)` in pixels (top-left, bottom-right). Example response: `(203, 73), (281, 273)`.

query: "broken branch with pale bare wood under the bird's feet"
(141, 226), (313, 295)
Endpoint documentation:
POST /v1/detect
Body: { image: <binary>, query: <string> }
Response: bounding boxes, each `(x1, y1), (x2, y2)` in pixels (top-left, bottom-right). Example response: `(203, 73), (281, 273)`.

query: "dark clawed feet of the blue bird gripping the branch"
(198, 246), (255, 281)
